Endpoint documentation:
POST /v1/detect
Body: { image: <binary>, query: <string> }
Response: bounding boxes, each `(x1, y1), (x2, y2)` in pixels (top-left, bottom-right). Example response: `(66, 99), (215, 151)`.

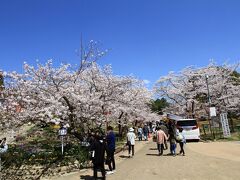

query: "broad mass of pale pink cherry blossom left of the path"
(1, 61), (156, 139)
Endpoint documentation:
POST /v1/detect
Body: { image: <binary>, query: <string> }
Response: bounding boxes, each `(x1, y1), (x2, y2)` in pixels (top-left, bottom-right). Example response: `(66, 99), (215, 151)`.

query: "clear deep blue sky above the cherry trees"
(0, 0), (240, 87)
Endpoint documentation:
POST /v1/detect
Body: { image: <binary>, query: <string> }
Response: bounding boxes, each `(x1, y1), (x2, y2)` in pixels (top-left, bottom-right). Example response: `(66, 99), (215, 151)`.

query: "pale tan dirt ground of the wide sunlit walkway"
(48, 141), (240, 180)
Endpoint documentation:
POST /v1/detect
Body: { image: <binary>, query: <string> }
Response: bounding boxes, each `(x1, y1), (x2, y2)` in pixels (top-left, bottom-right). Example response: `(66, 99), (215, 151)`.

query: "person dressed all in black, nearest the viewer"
(90, 132), (107, 180)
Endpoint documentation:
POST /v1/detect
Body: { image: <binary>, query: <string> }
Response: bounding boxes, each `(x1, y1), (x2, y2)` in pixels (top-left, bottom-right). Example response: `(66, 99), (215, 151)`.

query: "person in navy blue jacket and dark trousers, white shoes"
(106, 126), (116, 174)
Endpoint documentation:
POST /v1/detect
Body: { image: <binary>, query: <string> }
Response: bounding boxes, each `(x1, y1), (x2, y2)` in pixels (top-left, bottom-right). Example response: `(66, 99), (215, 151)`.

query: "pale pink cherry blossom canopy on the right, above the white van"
(155, 63), (240, 117)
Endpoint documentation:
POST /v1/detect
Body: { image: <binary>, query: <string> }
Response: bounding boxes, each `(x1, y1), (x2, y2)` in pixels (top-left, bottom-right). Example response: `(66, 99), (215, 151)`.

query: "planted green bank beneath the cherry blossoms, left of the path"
(2, 126), (88, 170)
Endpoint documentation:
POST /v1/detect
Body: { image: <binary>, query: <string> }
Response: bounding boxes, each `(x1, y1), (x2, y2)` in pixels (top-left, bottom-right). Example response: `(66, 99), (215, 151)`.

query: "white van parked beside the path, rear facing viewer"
(175, 119), (200, 141)
